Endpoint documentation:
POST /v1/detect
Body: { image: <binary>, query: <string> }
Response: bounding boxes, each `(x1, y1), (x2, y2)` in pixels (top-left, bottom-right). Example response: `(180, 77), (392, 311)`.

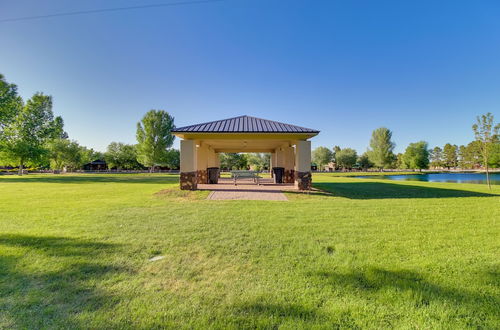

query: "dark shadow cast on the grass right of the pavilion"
(310, 182), (499, 199)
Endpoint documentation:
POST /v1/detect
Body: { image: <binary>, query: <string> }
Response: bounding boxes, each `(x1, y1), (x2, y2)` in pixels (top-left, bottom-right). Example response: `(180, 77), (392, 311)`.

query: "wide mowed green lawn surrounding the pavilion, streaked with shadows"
(0, 174), (500, 329)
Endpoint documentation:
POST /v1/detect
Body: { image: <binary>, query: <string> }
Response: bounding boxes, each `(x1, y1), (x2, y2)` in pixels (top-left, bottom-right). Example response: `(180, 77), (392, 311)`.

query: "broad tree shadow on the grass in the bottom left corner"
(0, 235), (129, 329)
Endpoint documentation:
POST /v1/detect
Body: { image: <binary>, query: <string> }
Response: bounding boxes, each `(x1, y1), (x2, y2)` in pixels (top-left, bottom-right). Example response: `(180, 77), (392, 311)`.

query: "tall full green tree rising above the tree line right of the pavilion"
(368, 127), (396, 169)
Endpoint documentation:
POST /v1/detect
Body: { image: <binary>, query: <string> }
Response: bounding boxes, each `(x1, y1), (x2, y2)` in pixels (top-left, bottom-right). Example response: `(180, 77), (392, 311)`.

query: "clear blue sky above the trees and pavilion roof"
(0, 0), (500, 152)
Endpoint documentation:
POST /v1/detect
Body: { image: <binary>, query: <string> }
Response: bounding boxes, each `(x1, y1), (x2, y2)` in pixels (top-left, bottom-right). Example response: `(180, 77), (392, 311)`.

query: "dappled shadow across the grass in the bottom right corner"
(312, 268), (500, 328)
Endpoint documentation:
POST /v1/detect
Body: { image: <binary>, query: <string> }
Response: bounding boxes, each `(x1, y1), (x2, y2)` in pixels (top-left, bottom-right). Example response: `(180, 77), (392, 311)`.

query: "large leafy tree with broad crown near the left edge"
(0, 93), (63, 175)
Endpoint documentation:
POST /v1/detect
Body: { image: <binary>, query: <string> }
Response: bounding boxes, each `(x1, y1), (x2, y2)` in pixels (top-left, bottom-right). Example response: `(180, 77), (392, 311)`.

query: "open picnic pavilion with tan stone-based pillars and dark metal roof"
(172, 116), (319, 190)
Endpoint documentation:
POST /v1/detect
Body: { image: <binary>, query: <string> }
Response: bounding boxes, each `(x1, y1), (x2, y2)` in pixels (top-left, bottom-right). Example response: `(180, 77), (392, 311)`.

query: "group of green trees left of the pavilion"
(0, 74), (180, 175)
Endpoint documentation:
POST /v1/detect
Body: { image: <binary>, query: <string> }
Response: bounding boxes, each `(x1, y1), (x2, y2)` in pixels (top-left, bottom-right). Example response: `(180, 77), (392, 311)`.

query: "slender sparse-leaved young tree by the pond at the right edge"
(472, 112), (500, 189)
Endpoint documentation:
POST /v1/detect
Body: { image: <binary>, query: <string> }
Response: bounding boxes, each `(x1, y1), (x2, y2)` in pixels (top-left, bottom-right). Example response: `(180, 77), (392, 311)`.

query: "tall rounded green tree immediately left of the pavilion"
(136, 110), (175, 172)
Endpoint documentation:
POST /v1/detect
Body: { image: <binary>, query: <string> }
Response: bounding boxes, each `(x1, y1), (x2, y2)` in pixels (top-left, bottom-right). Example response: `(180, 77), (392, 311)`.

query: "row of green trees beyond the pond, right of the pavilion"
(312, 113), (500, 175)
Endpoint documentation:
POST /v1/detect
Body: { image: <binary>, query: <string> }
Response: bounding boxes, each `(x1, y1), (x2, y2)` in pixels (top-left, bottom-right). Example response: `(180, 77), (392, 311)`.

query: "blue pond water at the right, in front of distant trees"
(357, 173), (500, 185)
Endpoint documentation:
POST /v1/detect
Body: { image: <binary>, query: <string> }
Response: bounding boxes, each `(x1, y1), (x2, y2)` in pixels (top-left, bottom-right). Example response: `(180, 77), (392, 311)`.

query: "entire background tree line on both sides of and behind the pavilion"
(0, 74), (500, 179)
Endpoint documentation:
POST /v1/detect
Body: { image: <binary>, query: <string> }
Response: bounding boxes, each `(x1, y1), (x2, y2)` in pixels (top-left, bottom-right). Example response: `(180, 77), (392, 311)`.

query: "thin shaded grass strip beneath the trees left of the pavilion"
(0, 174), (179, 184)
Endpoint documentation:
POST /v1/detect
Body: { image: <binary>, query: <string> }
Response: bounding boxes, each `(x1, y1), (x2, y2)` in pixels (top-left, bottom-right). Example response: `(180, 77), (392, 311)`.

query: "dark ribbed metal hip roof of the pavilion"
(172, 116), (319, 133)
